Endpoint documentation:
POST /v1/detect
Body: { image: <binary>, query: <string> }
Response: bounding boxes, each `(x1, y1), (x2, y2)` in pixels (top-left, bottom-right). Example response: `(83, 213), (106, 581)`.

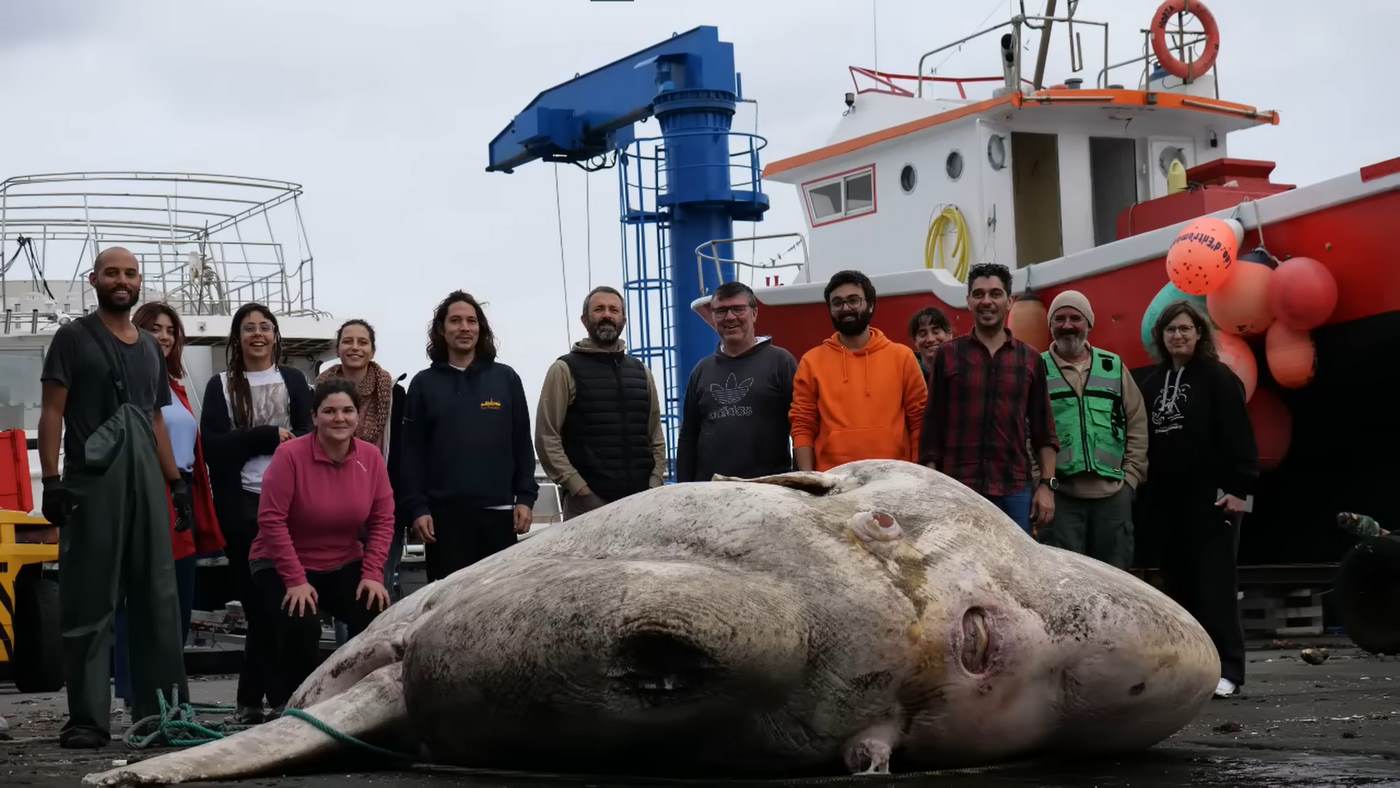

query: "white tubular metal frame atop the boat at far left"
(0, 171), (321, 316)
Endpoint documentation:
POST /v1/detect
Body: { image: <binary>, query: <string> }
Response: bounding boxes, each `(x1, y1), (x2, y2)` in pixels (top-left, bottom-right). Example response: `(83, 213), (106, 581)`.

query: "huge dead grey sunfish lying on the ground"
(87, 460), (1219, 785)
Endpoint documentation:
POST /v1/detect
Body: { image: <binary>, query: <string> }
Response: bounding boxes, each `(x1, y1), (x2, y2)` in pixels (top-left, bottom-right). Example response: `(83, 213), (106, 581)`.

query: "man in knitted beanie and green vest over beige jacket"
(1040, 290), (1148, 570)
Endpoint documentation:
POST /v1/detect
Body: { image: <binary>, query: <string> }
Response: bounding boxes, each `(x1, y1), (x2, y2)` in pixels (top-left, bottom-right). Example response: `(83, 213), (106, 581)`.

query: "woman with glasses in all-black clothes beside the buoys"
(1141, 301), (1259, 697)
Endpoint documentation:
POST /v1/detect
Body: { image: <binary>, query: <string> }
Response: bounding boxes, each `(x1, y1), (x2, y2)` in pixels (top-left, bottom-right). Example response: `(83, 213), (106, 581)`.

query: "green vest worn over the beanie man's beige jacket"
(1040, 347), (1127, 480)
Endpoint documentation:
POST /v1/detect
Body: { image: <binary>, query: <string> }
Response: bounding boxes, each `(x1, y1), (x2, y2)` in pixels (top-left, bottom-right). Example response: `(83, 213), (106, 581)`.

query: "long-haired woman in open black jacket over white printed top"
(200, 304), (311, 725)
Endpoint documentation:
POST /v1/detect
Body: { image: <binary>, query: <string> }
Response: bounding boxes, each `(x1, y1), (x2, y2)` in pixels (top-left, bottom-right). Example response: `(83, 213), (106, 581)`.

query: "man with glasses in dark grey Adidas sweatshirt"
(676, 281), (797, 481)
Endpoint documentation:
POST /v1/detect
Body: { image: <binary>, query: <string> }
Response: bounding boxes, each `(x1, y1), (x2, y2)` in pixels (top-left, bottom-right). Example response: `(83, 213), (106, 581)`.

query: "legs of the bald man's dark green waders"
(59, 474), (189, 739)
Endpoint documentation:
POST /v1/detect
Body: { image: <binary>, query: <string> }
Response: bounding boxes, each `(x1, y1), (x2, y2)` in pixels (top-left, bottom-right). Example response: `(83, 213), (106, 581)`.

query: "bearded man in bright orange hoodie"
(788, 270), (928, 470)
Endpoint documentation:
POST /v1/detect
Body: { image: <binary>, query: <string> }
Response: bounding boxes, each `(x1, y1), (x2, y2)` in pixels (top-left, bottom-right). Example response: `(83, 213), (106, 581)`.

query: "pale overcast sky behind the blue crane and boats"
(0, 0), (1400, 410)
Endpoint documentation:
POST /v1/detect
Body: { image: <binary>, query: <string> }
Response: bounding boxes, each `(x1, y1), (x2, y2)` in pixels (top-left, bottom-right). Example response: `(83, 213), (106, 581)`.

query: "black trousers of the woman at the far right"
(1148, 484), (1245, 684)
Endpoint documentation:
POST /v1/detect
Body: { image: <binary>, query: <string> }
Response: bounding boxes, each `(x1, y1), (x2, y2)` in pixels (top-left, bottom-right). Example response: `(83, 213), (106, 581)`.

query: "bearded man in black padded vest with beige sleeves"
(535, 286), (666, 519)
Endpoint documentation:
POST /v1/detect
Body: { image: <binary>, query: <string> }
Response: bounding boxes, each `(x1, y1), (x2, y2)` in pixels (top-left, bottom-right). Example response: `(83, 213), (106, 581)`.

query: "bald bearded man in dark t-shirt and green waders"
(39, 246), (193, 747)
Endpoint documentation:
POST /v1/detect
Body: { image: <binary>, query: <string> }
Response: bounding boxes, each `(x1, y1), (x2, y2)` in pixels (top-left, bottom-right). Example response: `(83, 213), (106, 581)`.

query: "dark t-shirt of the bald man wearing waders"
(41, 315), (171, 473)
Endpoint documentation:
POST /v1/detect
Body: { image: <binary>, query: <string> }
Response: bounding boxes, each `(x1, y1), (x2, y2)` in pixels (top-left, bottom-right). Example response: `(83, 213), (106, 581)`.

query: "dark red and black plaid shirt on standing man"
(920, 332), (1060, 495)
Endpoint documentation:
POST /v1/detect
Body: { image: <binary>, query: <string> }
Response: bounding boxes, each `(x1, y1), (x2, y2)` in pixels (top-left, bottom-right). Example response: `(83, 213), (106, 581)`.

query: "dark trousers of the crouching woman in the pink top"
(253, 561), (379, 708)
